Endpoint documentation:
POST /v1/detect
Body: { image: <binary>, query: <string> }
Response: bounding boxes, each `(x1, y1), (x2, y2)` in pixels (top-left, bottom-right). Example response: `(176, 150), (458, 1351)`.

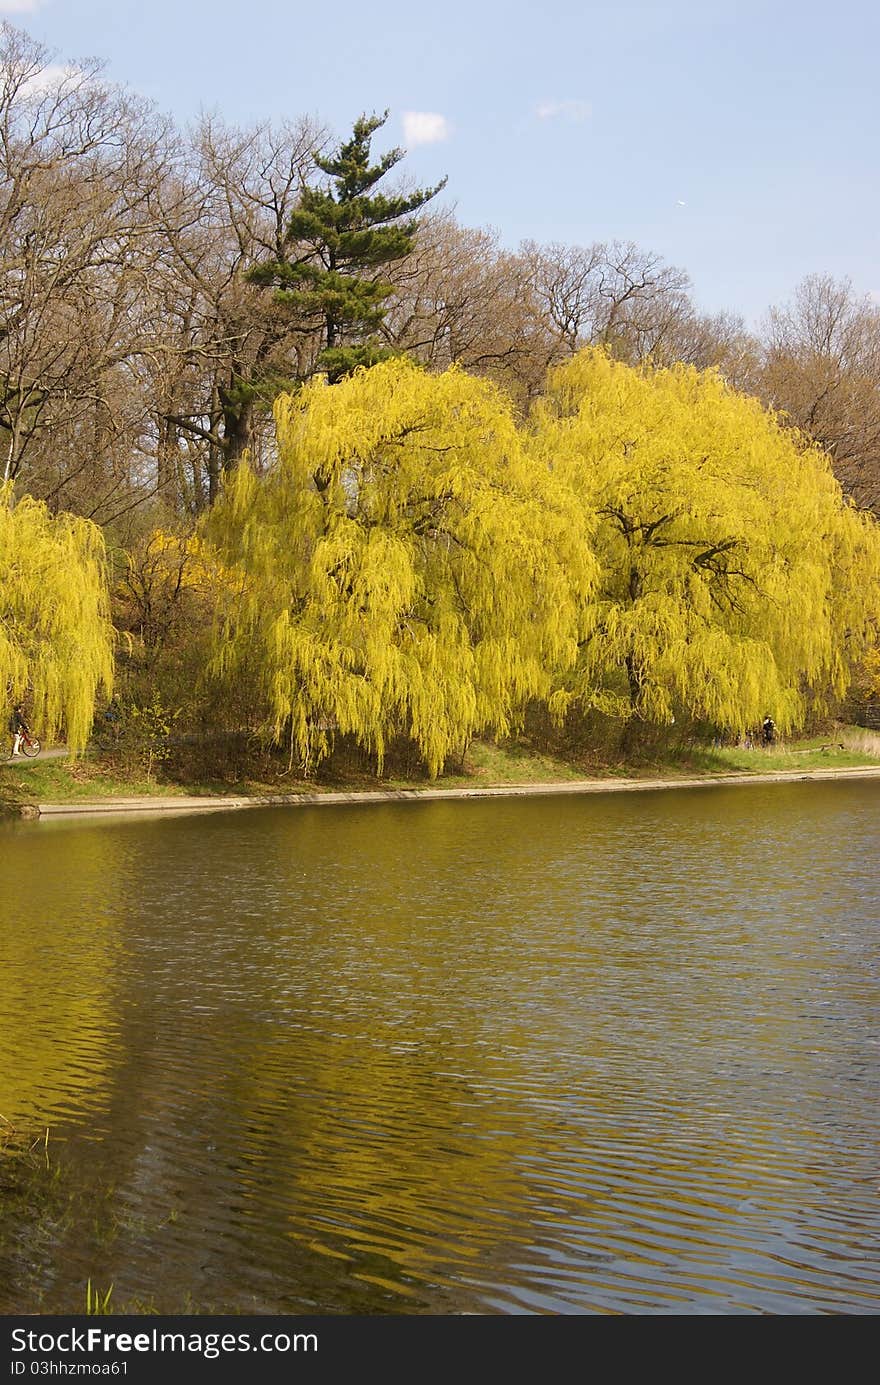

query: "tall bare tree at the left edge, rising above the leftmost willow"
(0, 25), (177, 519)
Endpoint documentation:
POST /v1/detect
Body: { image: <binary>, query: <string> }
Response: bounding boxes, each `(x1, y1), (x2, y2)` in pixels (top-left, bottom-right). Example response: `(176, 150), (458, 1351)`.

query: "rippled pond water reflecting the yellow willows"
(0, 781), (880, 1314)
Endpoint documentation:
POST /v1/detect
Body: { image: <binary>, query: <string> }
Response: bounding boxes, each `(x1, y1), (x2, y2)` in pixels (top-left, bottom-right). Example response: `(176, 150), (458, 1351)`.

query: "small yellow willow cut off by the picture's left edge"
(0, 486), (114, 751)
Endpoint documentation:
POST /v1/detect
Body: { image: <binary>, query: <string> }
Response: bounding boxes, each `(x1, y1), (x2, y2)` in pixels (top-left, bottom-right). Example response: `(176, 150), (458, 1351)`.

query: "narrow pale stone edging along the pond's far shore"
(32, 765), (880, 819)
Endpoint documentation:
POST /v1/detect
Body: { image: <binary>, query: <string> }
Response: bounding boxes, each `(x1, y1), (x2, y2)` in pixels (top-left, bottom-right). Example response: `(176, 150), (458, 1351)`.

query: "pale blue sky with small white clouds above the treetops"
(6, 0), (880, 328)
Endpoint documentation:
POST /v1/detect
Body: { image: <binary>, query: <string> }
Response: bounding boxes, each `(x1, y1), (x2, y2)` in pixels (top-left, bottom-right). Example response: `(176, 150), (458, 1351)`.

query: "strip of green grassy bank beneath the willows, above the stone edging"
(0, 726), (880, 813)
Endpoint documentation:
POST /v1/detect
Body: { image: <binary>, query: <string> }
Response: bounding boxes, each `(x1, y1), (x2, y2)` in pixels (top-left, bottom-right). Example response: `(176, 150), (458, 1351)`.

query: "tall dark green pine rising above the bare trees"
(251, 111), (446, 384)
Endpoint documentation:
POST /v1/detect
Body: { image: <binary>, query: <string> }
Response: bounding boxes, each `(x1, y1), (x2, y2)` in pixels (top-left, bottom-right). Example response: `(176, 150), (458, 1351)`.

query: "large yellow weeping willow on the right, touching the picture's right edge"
(532, 350), (880, 730)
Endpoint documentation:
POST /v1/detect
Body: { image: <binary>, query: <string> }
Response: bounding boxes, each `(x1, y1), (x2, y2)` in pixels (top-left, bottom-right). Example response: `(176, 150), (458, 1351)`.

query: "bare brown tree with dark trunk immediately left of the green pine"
(152, 119), (324, 508)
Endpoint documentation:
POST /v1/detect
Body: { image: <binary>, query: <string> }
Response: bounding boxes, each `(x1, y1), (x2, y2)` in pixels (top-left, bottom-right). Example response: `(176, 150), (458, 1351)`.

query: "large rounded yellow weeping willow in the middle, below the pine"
(206, 360), (596, 774)
